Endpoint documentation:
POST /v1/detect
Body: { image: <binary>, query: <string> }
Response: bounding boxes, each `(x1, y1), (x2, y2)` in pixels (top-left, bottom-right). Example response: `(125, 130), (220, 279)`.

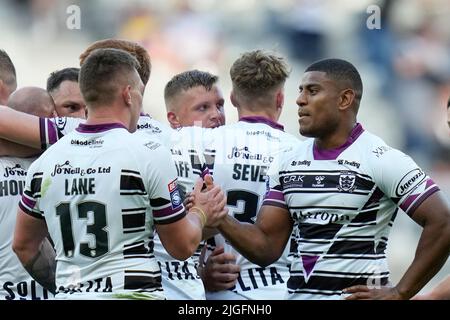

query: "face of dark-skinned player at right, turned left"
(296, 71), (339, 138)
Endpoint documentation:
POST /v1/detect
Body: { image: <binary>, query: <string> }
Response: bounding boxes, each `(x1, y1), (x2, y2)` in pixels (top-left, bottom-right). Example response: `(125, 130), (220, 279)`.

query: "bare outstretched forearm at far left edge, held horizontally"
(0, 106), (41, 149)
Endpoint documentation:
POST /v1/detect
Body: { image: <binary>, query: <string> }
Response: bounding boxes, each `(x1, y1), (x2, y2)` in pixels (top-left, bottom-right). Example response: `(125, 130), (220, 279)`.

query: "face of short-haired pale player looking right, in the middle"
(171, 86), (225, 128)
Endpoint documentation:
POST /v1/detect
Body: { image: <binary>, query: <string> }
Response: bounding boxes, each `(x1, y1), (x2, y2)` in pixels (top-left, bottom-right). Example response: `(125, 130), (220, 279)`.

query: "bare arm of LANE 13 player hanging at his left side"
(13, 208), (56, 293)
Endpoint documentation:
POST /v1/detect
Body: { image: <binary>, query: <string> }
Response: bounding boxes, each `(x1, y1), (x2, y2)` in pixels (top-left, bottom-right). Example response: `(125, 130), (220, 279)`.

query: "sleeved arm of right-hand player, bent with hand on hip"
(344, 149), (450, 300)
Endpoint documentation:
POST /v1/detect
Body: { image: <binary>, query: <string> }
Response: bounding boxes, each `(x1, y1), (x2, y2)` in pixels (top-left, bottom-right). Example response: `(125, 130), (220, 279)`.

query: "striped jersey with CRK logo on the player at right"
(263, 124), (438, 299)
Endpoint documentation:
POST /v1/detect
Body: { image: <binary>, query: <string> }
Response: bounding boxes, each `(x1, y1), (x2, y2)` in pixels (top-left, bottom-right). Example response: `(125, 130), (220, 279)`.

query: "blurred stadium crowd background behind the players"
(0, 0), (450, 292)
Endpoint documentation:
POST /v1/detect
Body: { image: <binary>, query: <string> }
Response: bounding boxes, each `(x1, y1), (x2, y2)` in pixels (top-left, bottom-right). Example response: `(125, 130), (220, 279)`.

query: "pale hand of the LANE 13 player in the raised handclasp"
(192, 175), (228, 228)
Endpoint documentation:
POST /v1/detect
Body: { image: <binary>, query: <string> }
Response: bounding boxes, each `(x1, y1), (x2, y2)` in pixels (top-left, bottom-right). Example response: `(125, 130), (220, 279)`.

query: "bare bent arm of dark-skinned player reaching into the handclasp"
(218, 205), (293, 267)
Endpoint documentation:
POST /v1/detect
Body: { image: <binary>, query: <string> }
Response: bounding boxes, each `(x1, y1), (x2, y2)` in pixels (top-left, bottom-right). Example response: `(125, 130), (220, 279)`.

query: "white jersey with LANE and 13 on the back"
(20, 124), (185, 299)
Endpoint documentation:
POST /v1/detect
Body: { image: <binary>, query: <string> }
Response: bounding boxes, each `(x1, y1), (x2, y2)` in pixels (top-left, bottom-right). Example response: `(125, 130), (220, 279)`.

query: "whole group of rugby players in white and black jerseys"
(0, 40), (450, 300)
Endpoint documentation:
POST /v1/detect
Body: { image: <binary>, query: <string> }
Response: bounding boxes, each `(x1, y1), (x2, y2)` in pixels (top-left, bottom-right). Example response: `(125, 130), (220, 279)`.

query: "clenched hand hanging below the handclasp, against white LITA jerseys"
(200, 246), (241, 292)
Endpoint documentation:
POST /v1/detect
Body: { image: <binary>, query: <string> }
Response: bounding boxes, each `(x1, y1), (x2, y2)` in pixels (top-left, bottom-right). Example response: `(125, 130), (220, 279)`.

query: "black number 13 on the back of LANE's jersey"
(56, 201), (109, 258)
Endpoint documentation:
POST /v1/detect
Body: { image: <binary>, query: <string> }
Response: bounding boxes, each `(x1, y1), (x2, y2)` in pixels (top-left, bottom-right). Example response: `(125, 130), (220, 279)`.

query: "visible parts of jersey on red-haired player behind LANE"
(40, 114), (205, 300)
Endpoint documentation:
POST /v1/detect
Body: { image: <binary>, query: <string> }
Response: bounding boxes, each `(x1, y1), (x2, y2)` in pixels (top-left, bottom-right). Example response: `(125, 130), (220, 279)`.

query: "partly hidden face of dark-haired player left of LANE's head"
(50, 81), (86, 118)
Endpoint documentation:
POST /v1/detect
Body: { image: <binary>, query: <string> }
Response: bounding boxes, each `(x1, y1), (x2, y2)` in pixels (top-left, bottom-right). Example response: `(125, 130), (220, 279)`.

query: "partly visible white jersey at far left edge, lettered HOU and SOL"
(0, 157), (53, 300)
